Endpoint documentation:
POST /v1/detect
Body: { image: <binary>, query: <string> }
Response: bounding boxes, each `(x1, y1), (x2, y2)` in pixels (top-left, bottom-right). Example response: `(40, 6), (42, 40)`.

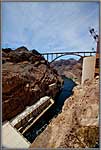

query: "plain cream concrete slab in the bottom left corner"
(2, 122), (31, 148)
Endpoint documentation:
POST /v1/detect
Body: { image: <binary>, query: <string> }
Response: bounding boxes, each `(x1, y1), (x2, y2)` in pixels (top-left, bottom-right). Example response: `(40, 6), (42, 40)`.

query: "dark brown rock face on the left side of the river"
(2, 47), (62, 121)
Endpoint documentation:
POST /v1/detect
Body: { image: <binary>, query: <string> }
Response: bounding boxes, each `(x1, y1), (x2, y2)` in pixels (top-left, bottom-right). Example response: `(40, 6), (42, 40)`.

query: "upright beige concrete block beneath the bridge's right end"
(81, 56), (96, 84)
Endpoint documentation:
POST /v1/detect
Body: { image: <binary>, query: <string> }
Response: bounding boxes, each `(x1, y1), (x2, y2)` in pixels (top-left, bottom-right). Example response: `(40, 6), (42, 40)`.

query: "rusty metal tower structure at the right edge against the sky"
(89, 28), (100, 76)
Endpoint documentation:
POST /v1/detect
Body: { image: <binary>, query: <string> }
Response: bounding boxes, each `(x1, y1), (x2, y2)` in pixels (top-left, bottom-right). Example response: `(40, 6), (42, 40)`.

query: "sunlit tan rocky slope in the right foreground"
(30, 78), (99, 148)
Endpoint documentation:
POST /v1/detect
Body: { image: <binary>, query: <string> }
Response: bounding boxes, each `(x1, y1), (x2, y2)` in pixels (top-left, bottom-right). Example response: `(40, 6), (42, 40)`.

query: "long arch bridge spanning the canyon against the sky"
(42, 51), (96, 63)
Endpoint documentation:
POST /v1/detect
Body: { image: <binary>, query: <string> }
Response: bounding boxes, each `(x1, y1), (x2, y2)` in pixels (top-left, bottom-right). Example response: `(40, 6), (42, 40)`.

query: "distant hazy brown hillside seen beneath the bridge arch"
(51, 58), (82, 83)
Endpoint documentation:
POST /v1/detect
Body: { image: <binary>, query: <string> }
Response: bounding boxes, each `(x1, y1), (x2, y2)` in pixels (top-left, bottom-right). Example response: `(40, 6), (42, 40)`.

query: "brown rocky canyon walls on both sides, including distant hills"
(2, 47), (99, 148)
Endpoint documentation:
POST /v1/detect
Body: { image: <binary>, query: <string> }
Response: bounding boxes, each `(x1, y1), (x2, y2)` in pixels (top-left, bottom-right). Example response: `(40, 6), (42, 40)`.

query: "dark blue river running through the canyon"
(24, 77), (76, 143)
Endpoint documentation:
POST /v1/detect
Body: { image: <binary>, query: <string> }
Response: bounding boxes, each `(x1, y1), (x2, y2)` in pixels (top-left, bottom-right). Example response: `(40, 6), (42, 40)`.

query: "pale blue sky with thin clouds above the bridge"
(2, 2), (99, 53)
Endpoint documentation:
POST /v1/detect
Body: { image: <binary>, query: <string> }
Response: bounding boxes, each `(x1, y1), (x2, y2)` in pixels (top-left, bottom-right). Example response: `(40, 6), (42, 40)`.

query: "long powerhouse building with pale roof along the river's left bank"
(10, 96), (54, 134)
